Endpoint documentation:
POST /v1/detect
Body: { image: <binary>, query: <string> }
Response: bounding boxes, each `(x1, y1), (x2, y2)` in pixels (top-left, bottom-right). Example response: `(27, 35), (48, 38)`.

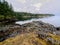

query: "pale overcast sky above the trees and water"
(6, 0), (60, 15)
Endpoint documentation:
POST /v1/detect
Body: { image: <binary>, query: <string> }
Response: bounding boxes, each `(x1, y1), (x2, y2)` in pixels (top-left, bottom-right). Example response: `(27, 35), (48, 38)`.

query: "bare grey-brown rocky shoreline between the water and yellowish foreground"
(0, 21), (60, 44)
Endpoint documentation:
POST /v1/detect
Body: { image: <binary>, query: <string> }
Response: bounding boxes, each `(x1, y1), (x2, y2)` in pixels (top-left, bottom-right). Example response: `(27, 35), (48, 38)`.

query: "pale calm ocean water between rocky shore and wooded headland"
(16, 16), (60, 27)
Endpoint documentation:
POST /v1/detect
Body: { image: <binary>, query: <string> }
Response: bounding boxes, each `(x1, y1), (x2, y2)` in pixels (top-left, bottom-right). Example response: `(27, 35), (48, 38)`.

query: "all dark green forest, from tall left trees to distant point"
(0, 0), (52, 22)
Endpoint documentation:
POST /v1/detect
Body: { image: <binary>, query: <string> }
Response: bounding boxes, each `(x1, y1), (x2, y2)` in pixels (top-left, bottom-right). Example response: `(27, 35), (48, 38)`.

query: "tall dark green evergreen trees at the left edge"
(0, 0), (14, 20)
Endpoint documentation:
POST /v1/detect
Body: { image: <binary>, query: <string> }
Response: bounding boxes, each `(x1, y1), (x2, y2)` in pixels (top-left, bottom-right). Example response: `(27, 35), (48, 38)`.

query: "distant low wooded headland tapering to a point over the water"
(15, 12), (53, 20)
